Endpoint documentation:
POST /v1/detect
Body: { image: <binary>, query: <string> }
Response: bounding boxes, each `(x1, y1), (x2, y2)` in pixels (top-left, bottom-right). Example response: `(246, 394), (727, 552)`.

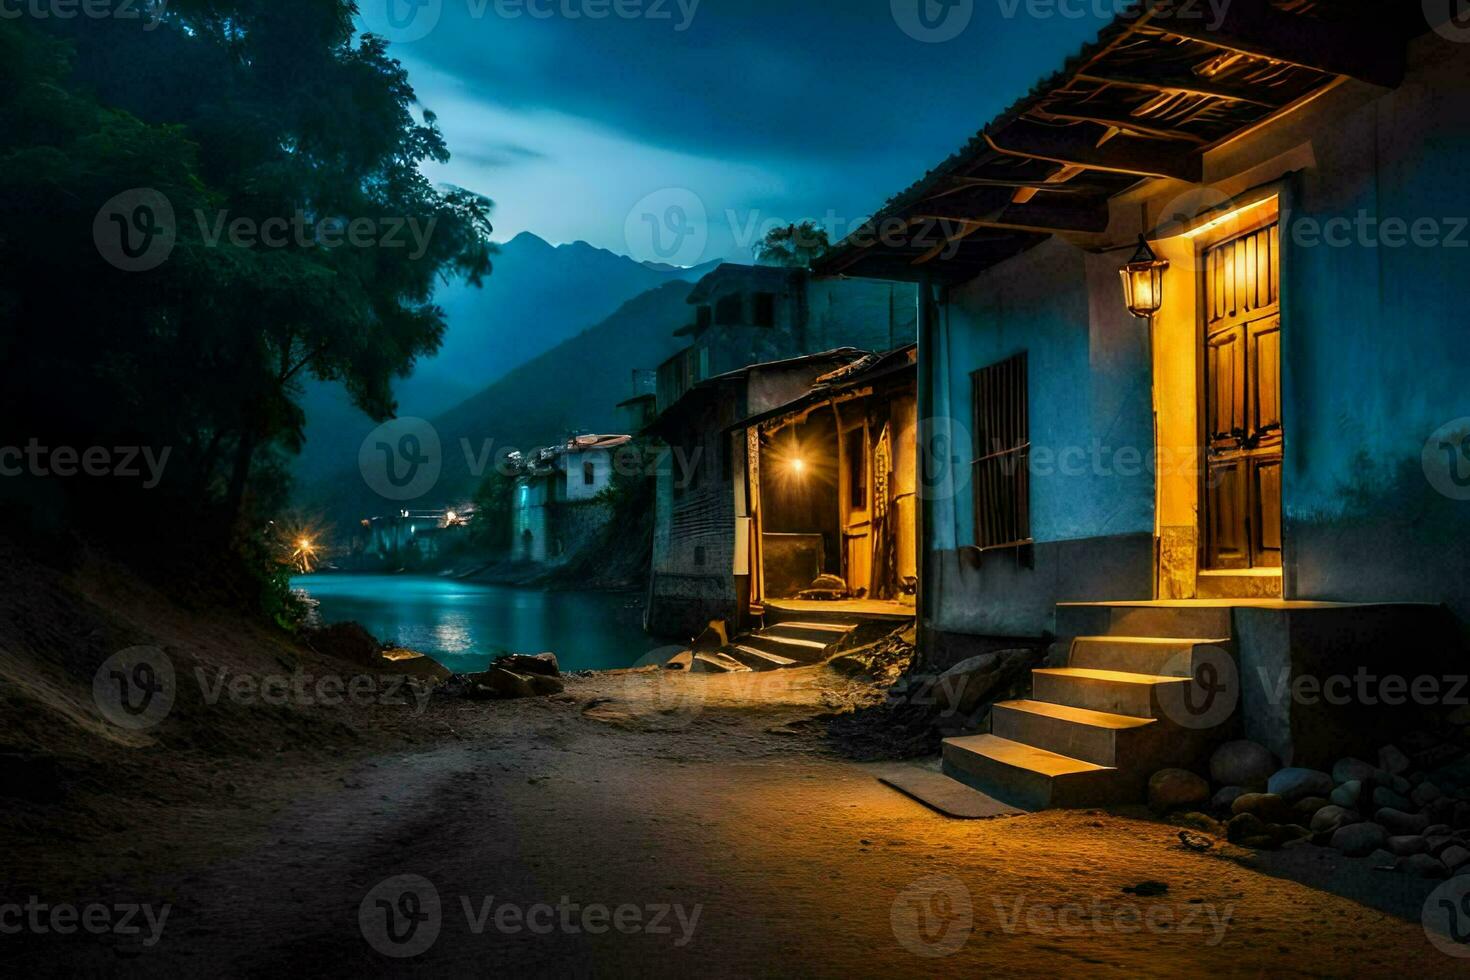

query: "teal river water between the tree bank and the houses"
(291, 574), (662, 673)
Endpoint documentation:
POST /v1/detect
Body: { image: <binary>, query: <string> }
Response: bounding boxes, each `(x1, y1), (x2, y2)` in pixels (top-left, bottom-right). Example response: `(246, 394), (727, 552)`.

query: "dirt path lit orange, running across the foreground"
(0, 670), (1461, 977)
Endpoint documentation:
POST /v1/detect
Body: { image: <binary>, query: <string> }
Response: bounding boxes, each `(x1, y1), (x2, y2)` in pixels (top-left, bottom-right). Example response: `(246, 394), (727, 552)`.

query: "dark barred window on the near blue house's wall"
(970, 353), (1030, 548)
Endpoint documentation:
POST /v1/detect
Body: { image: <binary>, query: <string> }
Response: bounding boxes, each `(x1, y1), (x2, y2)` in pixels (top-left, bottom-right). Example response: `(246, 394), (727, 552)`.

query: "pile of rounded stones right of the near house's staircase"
(1150, 733), (1470, 879)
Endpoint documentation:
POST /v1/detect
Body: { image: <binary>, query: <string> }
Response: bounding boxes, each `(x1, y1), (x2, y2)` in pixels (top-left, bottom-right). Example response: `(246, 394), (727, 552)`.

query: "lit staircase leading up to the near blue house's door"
(944, 602), (1235, 810)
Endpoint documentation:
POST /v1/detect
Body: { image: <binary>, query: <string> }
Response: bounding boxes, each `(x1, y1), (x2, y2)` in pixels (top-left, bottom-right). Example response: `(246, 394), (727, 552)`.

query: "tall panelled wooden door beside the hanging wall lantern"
(1202, 225), (1285, 569)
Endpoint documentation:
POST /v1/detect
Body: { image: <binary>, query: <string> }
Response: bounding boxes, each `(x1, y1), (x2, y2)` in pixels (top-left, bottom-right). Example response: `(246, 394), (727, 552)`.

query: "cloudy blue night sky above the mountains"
(360, 0), (1113, 266)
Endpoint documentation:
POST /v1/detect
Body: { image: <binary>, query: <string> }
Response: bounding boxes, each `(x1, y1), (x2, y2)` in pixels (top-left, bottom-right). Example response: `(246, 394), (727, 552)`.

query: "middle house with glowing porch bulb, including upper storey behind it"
(647, 264), (917, 658)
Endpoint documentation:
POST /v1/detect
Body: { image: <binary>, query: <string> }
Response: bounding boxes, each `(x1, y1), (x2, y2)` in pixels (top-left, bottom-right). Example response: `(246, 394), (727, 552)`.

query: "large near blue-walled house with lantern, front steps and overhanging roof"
(805, 0), (1470, 807)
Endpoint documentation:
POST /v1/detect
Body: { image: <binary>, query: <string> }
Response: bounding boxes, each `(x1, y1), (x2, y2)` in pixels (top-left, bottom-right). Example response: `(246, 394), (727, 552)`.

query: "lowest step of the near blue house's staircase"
(944, 735), (1141, 810)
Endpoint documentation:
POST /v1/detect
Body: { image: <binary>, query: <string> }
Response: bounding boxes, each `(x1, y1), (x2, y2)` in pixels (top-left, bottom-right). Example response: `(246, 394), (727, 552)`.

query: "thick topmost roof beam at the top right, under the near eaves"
(1144, 0), (1407, 88)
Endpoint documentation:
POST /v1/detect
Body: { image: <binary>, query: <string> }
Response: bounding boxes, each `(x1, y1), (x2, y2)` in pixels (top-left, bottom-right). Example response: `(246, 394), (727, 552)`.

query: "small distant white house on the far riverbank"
(510, 435), (632, 564)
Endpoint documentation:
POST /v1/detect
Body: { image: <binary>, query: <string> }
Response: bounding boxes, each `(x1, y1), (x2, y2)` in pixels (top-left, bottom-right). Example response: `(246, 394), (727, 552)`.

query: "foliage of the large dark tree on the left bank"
(0, 0), (492, 605)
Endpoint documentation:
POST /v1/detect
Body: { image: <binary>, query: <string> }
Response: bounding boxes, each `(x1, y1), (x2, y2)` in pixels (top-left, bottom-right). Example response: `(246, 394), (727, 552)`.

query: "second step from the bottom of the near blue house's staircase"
(991, 701), (1167, 770)
